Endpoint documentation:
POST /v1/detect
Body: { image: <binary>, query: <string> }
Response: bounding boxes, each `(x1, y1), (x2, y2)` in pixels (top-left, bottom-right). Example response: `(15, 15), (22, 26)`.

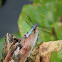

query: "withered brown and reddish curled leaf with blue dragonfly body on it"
(0, 23), (39, 62)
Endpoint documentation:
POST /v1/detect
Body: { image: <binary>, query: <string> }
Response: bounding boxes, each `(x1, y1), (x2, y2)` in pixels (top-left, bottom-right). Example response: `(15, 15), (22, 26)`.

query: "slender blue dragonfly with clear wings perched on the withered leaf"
(25, 16), (52, 39)
